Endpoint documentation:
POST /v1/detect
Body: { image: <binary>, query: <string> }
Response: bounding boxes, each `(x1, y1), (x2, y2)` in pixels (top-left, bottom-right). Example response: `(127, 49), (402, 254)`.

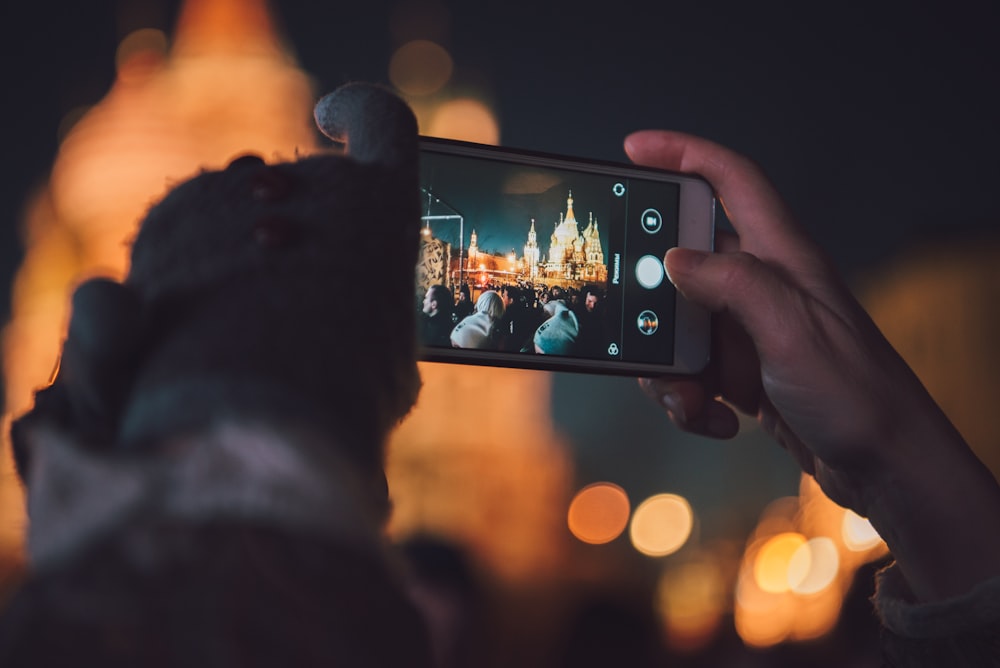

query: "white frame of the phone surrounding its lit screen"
(419, 136), (716, 376)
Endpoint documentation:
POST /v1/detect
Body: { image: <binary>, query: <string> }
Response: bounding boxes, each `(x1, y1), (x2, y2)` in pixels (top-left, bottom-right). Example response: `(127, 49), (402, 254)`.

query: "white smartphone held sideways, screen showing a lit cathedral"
(415, 137), (715, 375)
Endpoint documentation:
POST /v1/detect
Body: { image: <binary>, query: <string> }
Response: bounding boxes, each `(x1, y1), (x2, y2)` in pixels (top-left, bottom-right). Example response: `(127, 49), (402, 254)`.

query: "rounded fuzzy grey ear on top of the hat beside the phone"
(313, 82), (417, 168)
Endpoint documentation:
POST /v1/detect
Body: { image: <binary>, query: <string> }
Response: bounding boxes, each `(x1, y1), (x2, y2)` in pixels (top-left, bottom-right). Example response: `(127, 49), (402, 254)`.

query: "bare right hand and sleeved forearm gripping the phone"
(625, 130), (1000, 667)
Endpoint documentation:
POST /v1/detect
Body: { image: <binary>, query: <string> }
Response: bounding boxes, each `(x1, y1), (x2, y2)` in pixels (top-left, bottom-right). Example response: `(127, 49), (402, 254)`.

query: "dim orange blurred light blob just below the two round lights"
(657, 558), (725, 651)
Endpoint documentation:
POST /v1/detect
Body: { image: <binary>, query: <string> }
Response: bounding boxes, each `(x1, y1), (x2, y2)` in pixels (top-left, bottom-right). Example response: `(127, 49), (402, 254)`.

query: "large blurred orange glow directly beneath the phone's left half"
(386, 363), (573, 581)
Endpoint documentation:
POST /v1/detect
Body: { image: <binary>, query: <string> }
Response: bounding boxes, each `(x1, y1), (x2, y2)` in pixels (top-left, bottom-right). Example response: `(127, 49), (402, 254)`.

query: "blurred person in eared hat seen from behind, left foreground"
(0, 84), (430, 667)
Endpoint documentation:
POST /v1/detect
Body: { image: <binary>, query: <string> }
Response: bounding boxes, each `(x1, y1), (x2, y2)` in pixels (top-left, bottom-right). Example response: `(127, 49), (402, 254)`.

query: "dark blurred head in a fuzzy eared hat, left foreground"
(13, 84), (420, 490)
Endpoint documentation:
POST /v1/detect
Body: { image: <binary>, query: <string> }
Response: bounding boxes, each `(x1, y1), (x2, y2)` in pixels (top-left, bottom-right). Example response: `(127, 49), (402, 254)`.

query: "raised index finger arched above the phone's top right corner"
(625, 130), (812, 259)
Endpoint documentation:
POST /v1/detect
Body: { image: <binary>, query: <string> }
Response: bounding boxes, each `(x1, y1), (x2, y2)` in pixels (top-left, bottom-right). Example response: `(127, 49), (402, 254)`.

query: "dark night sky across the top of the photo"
(0, 0), (1000, 506)
